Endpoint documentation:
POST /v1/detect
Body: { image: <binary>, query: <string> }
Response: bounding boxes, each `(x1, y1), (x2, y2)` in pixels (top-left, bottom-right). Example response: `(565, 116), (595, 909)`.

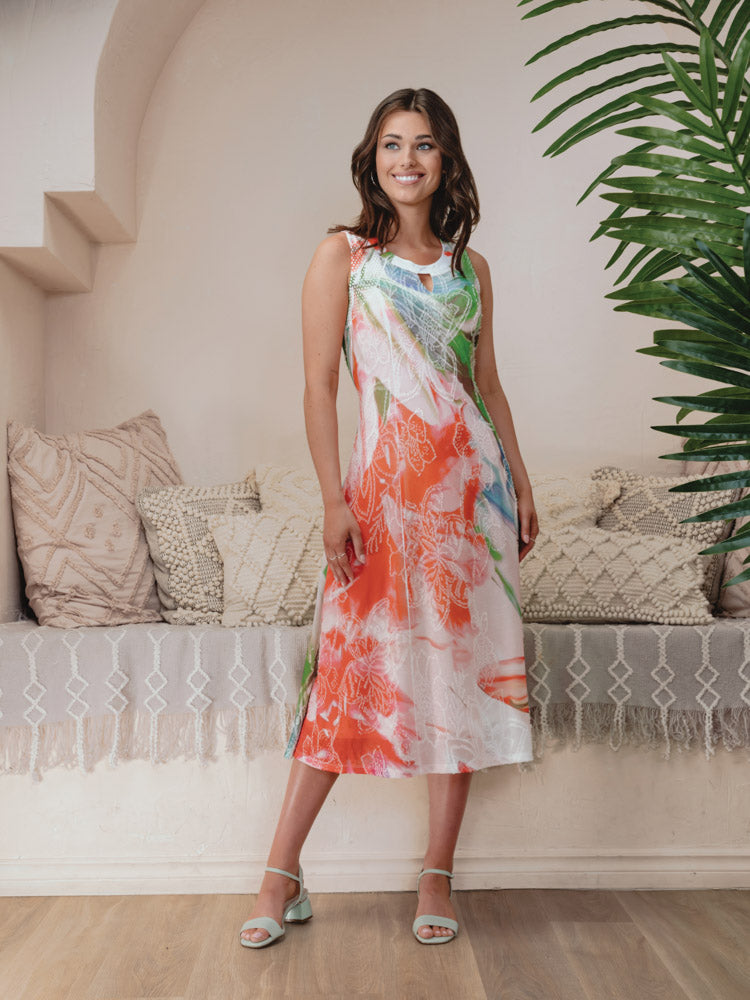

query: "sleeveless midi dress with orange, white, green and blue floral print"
(284, 231), (533, 777)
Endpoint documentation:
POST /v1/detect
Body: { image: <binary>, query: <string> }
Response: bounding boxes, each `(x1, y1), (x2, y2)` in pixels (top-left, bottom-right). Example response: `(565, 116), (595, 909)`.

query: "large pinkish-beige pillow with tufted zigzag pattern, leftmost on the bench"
(8, 410), (182, 628)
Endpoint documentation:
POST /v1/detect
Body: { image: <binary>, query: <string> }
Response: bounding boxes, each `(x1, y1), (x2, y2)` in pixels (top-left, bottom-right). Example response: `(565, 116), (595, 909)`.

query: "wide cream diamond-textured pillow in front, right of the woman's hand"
(520, 524), (713, 625)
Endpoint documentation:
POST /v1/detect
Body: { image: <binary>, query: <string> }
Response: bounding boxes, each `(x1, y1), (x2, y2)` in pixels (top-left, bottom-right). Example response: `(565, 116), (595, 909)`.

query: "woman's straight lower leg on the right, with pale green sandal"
(416, 771), (472, 938)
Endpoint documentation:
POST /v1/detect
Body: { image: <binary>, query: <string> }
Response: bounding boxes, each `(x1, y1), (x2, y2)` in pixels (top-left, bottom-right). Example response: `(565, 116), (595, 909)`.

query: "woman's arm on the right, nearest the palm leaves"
(467, 250), (539, 558)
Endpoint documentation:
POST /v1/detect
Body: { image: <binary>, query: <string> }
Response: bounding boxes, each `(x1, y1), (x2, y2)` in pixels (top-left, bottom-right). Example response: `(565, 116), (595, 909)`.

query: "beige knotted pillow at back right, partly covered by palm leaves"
(591, 465), (740, 606)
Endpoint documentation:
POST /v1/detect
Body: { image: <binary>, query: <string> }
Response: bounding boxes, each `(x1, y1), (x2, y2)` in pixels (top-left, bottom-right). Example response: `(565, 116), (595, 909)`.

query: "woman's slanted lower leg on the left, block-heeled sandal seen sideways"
(242, 758), (338, 941)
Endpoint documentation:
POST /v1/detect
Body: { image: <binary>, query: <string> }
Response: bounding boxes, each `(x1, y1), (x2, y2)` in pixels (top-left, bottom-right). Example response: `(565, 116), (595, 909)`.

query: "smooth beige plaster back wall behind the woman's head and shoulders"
(45, 0), (686, 494)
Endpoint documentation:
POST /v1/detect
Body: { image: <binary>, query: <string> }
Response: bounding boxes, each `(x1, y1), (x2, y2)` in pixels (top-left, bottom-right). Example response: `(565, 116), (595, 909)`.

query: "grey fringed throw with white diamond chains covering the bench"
(0, 617), (750, 779)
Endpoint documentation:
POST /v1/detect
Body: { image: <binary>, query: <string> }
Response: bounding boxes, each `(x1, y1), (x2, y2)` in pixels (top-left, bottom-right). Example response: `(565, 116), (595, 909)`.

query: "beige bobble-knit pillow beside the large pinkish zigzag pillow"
(136, 470), (260, 625)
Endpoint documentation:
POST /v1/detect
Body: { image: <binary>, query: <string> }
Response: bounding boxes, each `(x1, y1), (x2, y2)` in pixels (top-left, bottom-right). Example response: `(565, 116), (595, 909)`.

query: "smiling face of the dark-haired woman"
(375, 111), (443, 206)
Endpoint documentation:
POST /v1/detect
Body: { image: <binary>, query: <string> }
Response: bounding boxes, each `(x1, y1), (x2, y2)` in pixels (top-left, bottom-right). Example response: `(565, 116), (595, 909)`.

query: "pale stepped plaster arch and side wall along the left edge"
(0, 0), (203, 621)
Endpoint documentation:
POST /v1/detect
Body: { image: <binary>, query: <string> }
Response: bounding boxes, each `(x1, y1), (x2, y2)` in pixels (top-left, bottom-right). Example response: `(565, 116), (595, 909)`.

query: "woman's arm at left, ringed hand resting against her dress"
(302, 233), (364, 583)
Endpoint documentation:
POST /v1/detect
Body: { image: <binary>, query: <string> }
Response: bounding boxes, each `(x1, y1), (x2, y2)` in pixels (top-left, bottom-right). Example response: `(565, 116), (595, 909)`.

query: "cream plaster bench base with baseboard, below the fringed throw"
(0, 745), (750, 892)
